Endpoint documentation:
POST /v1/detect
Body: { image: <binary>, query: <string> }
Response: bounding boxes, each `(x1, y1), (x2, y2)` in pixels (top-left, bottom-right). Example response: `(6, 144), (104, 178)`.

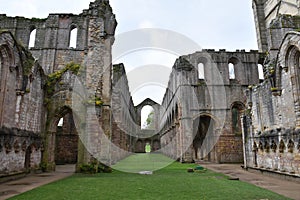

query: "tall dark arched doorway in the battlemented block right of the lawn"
(192, 115), (216, 161)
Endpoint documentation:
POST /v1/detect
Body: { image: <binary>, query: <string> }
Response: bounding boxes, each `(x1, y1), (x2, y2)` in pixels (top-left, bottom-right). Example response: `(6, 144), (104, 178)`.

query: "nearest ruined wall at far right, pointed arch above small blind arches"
(246, 32), (300, 175)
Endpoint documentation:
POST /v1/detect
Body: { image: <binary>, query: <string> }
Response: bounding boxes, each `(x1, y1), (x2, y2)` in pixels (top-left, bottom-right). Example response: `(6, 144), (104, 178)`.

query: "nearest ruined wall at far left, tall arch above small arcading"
(0, 31), (45, 174)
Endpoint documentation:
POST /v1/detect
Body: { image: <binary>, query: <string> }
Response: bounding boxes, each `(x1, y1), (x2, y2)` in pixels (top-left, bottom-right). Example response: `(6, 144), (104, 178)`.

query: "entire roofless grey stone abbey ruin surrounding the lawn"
(0, 0), (300, 177)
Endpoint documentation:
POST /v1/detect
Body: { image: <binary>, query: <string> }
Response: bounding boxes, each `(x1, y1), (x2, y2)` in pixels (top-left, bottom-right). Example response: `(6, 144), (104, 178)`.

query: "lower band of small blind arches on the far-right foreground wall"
(247, 129), (300, 176)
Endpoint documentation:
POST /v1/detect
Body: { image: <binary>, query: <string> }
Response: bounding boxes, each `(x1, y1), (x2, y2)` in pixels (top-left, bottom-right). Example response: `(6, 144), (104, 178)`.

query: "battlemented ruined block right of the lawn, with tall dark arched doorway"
(160, 50), (260, 162)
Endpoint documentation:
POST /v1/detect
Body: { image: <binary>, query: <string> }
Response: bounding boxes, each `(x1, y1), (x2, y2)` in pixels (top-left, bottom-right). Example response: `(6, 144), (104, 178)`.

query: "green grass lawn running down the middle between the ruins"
(11, 154), (288, 200)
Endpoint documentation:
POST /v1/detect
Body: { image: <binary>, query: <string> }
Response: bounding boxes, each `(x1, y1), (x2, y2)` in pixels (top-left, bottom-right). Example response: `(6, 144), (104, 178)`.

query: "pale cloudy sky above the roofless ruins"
(0, 0), (258, 123)
